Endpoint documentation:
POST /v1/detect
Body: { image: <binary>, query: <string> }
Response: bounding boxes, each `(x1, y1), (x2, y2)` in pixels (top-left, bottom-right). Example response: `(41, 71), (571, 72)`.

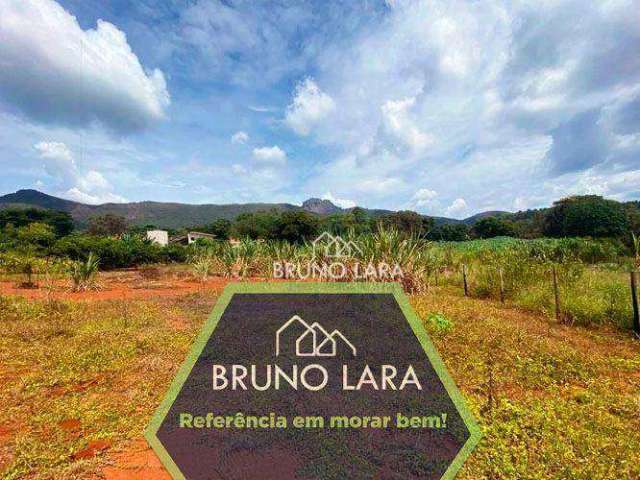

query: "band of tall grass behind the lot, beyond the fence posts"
(182, 233), (633, 328)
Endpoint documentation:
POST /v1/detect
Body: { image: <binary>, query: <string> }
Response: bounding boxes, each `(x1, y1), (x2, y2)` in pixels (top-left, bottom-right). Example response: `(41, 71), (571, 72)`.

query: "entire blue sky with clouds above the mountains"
(0, 0), (640, 218)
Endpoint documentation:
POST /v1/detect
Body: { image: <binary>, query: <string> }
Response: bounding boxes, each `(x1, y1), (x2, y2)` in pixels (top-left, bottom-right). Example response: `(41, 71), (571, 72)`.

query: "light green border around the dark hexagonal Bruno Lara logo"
(144, 282), (482, 480)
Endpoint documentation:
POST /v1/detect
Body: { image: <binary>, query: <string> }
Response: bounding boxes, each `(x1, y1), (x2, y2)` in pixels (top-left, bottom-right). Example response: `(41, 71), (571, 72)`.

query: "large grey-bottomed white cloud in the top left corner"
(0, 0), (170, 133)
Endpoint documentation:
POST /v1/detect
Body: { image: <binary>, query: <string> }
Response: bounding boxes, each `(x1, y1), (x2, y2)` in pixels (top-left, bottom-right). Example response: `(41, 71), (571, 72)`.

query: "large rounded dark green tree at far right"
(544, 195), (629, 237)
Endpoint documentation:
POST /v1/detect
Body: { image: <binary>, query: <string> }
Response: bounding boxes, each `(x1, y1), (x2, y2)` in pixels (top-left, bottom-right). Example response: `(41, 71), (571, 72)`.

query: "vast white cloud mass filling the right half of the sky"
(288, 0), (640, 214)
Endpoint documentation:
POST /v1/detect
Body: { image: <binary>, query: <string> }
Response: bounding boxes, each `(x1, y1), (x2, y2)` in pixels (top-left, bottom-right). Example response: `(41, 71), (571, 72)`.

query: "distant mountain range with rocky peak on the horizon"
(0, 190), (508, 228)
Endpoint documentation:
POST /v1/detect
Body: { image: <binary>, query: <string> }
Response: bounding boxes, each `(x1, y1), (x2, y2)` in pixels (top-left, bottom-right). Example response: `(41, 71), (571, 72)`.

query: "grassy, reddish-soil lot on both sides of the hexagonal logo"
(0, 271), (640, 480)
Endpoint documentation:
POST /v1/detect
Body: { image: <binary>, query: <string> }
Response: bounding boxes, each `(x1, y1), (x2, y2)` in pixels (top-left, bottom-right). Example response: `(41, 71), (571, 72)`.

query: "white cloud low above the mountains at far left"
(34, 142), (126, 204)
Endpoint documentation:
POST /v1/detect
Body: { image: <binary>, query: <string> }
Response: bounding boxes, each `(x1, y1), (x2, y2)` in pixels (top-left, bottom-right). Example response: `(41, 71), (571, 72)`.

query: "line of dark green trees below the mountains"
(0, 195), (640, 246)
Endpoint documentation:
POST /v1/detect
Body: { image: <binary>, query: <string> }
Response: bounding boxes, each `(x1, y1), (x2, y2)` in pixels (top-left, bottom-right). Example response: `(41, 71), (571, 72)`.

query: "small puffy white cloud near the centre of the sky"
(285, 78), (336, 135)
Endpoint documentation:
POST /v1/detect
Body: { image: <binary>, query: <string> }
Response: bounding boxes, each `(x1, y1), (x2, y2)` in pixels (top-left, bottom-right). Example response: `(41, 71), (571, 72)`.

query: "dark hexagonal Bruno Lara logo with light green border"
(146, 283), (480, 480)
